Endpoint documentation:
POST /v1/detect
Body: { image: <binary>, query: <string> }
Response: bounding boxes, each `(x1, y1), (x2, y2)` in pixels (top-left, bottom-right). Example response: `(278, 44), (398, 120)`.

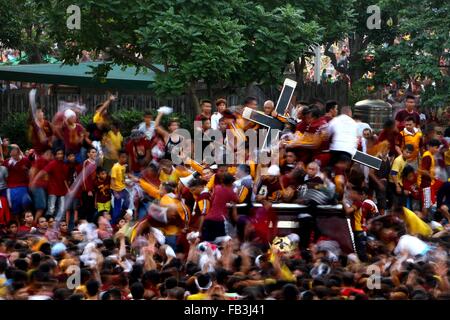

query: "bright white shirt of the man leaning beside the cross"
(328, 114), (358, 155)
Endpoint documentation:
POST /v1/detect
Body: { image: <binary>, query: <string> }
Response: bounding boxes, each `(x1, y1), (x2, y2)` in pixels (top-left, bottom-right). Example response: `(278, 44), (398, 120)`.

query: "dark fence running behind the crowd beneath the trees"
(0, 82), (348, 122)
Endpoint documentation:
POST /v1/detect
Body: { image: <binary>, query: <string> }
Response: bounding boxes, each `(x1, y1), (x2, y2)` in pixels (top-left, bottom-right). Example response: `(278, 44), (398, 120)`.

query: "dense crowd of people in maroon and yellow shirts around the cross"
(0, 89), (450, 300)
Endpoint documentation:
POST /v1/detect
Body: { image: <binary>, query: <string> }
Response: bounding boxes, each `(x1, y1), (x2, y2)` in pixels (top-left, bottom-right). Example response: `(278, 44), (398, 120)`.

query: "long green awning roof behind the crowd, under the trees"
(0, 62), (162, 90)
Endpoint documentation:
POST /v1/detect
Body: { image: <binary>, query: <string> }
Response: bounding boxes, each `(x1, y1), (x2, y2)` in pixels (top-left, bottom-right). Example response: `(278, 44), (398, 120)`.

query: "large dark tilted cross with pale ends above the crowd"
(242, 79), (297, 147)
